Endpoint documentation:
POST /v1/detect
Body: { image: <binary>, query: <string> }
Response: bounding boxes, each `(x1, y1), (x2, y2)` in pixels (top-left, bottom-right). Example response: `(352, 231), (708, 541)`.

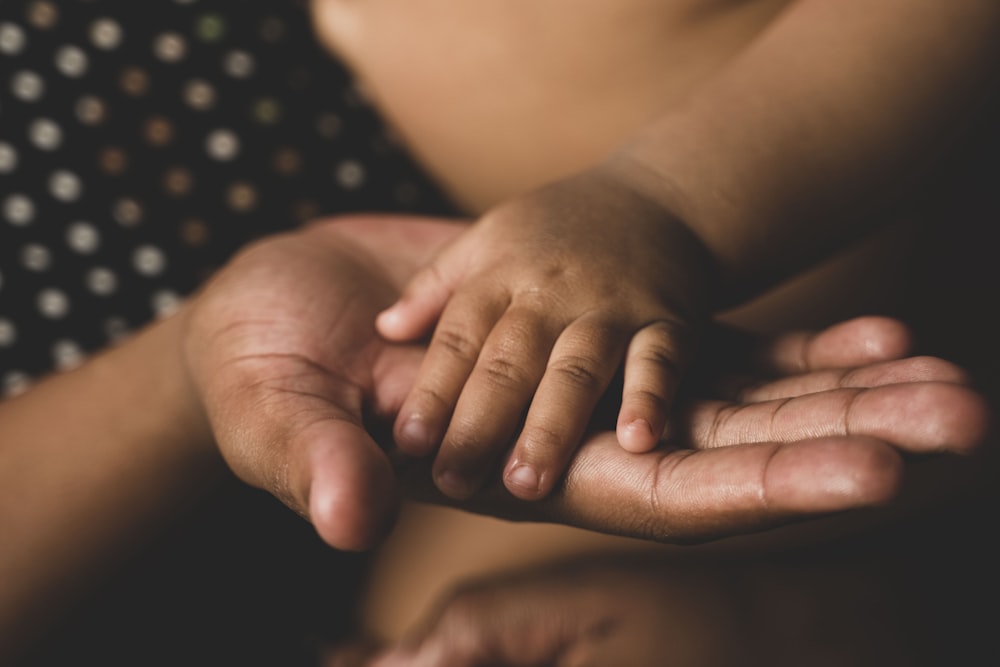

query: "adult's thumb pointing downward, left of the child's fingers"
(201, 357), (398, 550)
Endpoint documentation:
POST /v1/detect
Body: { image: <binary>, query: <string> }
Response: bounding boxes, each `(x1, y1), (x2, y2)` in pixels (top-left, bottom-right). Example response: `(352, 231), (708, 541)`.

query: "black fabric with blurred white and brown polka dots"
(0, 0), (452, 395)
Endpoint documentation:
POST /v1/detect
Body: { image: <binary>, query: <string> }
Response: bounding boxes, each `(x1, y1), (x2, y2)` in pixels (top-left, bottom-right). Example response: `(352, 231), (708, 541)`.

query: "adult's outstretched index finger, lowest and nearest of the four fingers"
(540, 434), (916, 544)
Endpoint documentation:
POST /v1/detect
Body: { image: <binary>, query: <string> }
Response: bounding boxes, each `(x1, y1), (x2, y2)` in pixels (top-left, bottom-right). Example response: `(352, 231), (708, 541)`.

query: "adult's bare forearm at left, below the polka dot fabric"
(0, 310), (218, 661)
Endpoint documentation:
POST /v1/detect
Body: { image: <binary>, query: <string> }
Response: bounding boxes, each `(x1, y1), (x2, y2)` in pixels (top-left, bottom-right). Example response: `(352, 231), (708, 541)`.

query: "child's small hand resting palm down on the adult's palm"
(377, 171), (707, 499)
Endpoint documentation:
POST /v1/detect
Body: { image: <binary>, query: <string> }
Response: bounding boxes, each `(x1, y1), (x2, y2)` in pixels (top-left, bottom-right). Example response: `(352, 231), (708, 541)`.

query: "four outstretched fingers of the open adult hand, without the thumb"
(402, 317), (990, 543)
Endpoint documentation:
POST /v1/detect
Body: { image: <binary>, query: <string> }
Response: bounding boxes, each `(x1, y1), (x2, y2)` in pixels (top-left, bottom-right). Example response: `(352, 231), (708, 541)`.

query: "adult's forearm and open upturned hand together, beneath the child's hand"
(0, 216), (988, 658)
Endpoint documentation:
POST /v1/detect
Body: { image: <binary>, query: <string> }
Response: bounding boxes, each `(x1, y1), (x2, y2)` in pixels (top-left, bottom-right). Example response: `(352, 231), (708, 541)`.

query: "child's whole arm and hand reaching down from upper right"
(379, 0), (1000, 498)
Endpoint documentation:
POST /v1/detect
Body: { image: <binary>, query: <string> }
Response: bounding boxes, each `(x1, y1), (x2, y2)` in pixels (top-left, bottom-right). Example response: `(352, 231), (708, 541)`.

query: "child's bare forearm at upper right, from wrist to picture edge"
(622, 0), (1000, 306)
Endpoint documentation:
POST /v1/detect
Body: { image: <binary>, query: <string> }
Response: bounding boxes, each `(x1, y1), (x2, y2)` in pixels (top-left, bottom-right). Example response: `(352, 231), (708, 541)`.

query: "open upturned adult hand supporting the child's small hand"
(185, 216), (987, 549)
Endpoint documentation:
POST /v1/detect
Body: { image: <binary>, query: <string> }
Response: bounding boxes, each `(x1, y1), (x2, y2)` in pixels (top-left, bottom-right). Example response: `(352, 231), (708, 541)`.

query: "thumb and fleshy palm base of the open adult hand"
(184, 218), (461, 550)
